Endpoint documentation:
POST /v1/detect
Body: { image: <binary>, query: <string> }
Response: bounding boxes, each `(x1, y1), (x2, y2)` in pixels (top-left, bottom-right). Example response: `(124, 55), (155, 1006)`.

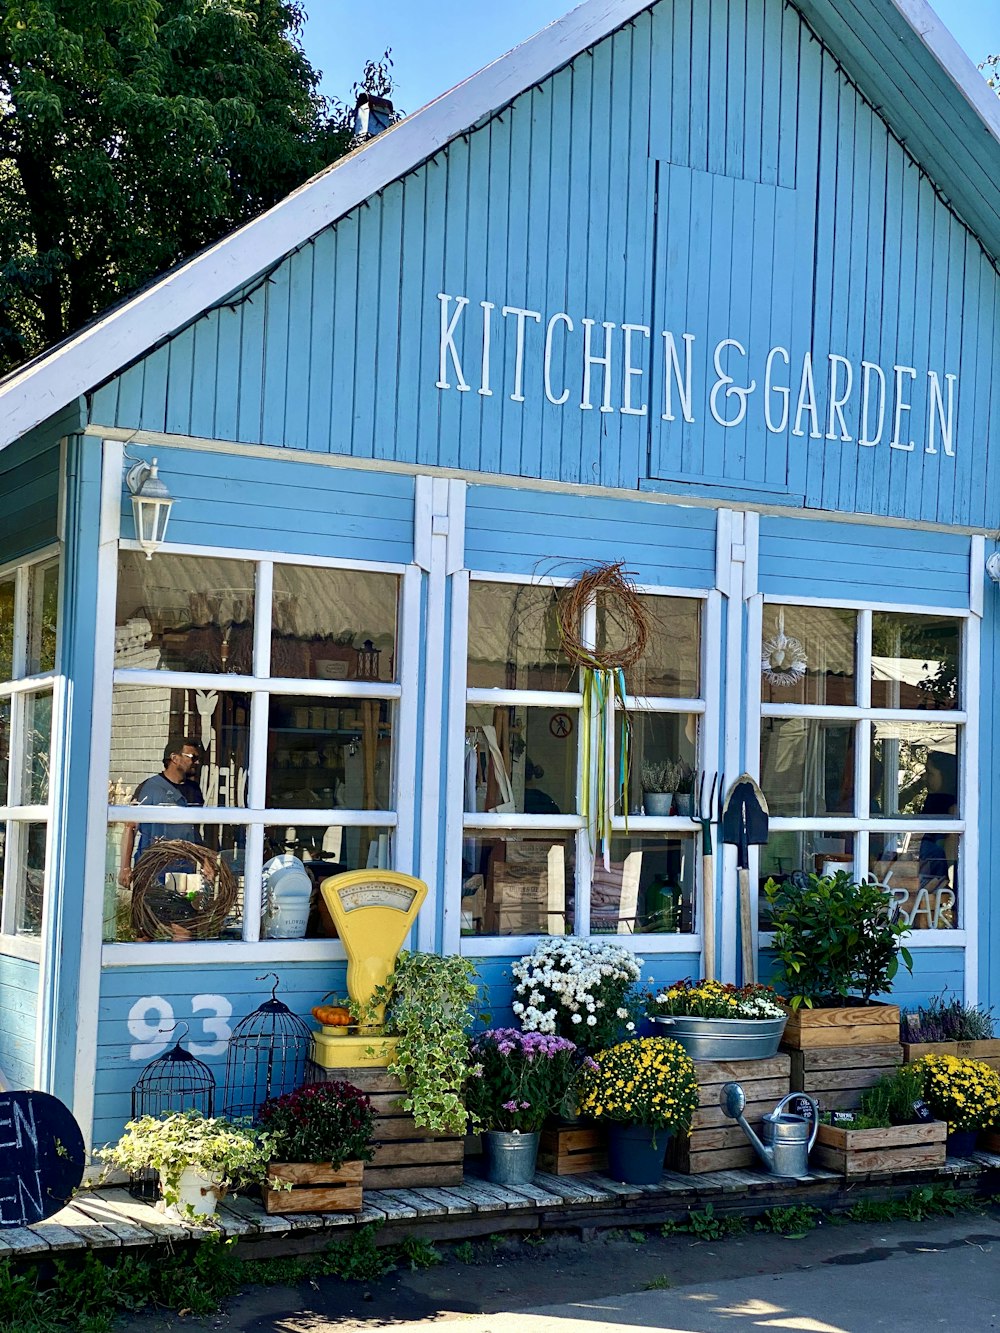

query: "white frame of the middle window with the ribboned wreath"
(453, 571), (723, 958)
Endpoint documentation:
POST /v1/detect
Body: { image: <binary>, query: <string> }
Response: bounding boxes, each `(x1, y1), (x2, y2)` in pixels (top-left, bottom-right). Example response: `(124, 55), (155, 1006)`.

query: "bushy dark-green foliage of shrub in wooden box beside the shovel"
(764, 870), (913, 1009)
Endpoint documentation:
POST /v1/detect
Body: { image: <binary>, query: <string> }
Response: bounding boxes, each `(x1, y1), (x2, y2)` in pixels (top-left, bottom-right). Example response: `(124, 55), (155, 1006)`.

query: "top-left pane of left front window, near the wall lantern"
(115, 551), (255, 676)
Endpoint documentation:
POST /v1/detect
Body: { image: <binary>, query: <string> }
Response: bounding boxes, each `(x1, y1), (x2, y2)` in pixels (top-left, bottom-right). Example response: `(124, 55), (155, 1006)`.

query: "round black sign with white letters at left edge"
(0, 1092), (85, 1229)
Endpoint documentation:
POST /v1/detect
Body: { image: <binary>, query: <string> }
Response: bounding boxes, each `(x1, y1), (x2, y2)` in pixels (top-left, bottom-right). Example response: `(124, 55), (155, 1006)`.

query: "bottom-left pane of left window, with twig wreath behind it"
(104, 821), (245, 942)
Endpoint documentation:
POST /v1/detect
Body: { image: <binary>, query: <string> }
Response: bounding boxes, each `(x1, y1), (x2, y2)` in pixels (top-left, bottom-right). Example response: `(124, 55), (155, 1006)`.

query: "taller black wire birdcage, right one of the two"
(223, 972), (312, 1120)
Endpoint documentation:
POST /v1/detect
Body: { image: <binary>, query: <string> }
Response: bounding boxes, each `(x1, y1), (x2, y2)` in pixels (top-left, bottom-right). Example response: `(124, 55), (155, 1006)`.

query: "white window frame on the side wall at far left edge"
(0, 543), (65, 962)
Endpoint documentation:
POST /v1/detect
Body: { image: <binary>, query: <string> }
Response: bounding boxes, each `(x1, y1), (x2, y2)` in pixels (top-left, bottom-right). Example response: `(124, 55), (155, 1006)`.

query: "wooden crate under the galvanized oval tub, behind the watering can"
(667, 1053), (792, 1176)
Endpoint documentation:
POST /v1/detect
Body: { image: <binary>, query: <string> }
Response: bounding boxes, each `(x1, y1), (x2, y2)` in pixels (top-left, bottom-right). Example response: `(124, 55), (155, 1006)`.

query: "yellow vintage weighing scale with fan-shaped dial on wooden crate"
(312, 870), (427, 1069)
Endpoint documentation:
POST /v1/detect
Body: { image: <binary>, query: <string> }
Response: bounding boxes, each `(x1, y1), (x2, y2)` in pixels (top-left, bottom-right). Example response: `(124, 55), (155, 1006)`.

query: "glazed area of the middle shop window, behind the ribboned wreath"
(461, 576), (705, 946)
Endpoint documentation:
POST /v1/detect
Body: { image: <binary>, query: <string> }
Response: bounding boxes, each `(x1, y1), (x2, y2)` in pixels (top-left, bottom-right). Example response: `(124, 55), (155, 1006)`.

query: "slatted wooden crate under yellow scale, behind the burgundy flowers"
(307, 1064), (465, 1189)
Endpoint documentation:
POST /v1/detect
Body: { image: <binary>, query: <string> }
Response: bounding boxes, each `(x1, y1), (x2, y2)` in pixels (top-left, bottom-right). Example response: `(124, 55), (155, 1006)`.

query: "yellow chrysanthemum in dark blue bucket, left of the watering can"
(580, 1037), (699, 1185)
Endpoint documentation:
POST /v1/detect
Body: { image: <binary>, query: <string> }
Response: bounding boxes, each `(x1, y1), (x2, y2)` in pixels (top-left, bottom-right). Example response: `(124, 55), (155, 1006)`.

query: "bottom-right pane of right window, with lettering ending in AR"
(869, 829), (961, 930)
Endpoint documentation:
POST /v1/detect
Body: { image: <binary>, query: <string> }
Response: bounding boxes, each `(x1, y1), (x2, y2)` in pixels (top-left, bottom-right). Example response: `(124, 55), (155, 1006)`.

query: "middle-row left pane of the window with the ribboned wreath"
(465, 704), (580, 814)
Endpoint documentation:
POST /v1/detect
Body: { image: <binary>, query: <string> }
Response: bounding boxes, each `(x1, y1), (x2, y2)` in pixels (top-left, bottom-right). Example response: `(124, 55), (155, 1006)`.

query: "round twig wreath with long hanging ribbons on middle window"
(557, 560), (649, 869)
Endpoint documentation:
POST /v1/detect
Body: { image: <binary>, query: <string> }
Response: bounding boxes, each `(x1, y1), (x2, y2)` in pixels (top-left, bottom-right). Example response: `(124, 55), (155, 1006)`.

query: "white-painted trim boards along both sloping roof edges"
(0, 0), (1000, 449)
